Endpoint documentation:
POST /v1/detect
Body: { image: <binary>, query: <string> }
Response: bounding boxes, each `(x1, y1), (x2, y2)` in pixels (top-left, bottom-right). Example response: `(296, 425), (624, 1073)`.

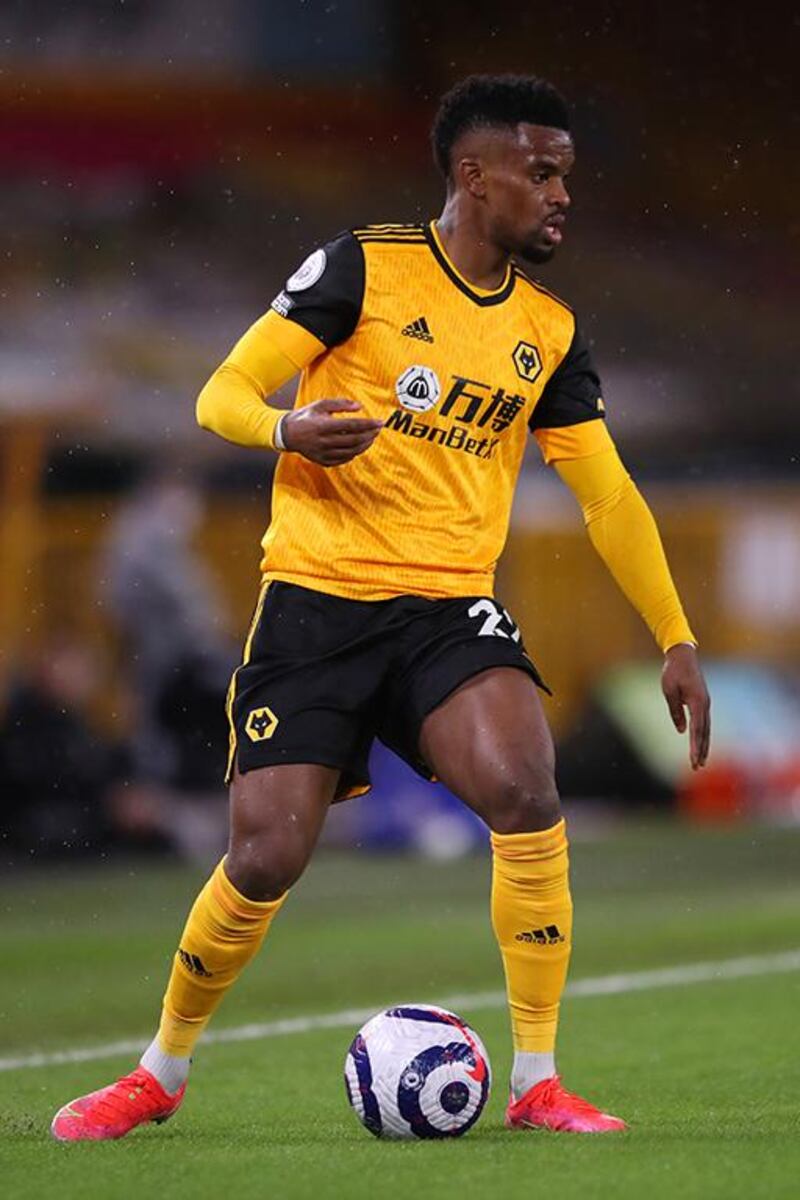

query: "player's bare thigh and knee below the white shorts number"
(420, 667), (559, 833)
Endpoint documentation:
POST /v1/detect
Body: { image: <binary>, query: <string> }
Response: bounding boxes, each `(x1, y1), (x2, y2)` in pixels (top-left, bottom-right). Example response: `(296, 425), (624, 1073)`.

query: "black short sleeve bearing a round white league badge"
(270, 233), (365, 349)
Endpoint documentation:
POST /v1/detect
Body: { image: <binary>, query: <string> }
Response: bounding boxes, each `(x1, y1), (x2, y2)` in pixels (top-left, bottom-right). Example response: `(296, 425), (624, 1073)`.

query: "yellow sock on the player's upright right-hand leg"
(492, 821), (572, 1054)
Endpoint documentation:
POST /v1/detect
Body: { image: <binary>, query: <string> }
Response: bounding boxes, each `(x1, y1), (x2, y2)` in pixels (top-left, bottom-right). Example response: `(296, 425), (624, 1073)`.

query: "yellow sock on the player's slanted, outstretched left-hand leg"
(158, 859), (285, 1057)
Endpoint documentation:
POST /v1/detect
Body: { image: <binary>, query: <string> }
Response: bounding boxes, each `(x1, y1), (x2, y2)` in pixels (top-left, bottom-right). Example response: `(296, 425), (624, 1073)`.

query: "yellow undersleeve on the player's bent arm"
(197, 312), (325, 449)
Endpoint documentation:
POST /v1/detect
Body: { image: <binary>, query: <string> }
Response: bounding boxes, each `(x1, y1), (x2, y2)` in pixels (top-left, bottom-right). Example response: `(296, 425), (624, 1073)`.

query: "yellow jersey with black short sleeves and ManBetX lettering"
(261, 223), (603, 600)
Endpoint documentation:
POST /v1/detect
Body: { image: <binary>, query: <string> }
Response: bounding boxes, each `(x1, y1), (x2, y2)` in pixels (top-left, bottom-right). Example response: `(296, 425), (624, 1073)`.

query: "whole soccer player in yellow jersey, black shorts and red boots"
(53, 76), (709, 1141)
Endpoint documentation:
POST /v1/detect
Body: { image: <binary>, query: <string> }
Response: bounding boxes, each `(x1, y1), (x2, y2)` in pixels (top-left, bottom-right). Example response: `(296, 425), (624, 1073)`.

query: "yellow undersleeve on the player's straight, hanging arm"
(554, 432), (697, 652)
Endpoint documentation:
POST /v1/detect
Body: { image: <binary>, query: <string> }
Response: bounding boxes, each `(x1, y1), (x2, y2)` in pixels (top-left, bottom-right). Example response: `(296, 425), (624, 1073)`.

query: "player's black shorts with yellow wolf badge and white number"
(228, 582), (547, 798)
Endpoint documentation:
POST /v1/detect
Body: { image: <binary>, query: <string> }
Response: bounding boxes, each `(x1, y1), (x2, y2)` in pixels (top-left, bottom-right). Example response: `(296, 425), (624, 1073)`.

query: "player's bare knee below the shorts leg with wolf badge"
(225, 763), (339, 899)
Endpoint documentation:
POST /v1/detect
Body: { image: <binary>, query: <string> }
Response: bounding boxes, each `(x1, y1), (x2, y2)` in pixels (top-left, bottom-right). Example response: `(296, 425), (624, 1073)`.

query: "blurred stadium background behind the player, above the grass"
(0, 0), (800, 859)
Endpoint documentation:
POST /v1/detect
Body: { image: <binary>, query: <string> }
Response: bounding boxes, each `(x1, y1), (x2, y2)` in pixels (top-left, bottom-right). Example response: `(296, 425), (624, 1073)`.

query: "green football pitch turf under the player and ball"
(0, 823), (800, 1200)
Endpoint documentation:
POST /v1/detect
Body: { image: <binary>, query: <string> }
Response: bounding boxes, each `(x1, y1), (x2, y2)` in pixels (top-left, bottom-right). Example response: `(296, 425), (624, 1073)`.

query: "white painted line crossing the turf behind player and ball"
(0, 949), (800, 1072)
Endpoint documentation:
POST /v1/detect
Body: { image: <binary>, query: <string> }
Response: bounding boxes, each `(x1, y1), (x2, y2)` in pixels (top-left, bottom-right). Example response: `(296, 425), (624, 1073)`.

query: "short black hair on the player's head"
(431, 74), (570, 179)
